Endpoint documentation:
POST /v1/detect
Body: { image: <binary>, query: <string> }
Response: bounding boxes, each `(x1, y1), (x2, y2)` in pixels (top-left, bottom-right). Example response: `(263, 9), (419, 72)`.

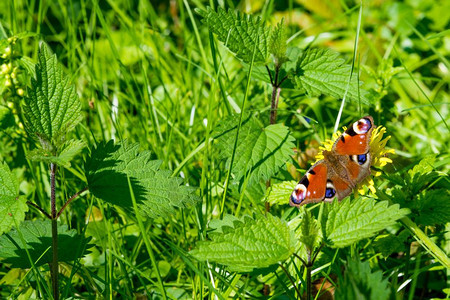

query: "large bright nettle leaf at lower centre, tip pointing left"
(190, 214), (296, 272)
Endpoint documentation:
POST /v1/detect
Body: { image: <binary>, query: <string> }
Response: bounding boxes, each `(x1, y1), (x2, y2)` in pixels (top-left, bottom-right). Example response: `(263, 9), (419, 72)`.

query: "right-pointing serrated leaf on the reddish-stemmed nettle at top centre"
(291, 48), (369, 103)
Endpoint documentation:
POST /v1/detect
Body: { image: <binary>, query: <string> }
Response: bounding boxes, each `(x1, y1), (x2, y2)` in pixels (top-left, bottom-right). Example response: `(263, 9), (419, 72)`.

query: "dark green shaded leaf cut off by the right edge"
(411, 189), (450, 226)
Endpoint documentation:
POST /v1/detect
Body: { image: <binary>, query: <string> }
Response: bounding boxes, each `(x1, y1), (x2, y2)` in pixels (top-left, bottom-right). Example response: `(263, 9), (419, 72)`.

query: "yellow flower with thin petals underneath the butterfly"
(316, 126), (395, 195)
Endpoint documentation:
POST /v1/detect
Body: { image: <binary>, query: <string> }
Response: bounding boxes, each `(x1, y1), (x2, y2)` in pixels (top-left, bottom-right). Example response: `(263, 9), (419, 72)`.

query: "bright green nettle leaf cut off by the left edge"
(0, 162), (28, 234)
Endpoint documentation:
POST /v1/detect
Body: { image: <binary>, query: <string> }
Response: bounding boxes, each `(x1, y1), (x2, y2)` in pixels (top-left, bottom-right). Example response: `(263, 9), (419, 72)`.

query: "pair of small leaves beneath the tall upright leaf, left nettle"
(27, 140), (86, 168)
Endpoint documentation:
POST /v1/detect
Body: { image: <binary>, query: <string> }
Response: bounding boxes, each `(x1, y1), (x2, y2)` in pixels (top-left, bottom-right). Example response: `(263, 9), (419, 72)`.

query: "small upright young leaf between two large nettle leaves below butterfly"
(296, 207), (322, 252)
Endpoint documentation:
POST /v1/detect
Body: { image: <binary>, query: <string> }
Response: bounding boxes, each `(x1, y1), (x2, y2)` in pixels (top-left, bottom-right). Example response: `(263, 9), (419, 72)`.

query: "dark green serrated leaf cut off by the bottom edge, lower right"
(335, 260), (391, 300)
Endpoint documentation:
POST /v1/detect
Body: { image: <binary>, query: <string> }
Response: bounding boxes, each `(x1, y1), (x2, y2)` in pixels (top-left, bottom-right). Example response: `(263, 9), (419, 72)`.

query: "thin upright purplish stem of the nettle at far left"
(50, 163), (59, 300)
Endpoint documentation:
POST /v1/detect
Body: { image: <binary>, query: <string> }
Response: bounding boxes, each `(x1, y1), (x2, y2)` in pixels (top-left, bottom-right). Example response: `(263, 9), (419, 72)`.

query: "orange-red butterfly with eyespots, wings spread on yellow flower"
(289, 116), (375, 206)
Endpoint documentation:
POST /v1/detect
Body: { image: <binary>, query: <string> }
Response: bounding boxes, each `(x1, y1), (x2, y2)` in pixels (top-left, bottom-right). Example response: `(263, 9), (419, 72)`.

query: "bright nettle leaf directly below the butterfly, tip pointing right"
(326, 198), (409, 248)
